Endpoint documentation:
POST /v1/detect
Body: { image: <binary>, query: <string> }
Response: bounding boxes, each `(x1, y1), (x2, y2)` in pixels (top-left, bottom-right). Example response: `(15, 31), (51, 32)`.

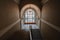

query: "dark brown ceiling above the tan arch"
(14, 0), (48, 9)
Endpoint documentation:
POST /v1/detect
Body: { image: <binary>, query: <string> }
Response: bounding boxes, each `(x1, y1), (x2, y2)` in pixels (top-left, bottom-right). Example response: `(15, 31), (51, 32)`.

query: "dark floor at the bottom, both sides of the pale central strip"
(7, 29), (42, 40)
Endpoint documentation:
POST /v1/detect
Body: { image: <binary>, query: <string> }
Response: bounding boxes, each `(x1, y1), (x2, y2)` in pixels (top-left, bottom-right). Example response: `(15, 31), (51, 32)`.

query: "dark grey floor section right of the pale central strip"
(31, 29), (42, 40)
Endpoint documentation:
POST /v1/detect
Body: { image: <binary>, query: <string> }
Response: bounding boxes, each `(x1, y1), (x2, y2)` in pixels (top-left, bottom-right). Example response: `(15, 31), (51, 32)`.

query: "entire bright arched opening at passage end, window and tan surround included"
(21, 4), (40, 30)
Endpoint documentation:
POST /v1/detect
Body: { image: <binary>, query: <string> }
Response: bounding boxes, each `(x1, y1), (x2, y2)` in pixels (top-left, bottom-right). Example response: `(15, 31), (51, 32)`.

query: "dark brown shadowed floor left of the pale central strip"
(7, 30), (29, 40)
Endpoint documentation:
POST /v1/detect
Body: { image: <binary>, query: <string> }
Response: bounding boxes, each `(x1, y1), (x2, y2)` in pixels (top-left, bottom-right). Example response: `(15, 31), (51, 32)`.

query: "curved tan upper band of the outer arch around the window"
(21, 4), (40, 18)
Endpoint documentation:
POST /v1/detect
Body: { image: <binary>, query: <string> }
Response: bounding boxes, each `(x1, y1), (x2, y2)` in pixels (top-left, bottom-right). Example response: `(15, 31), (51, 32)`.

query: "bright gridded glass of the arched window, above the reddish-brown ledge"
(25, 9), (35, 23)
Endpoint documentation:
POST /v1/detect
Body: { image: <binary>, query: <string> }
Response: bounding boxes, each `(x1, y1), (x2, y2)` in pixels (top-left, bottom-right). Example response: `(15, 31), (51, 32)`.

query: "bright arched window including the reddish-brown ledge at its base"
(24, 9), (36, 24)
